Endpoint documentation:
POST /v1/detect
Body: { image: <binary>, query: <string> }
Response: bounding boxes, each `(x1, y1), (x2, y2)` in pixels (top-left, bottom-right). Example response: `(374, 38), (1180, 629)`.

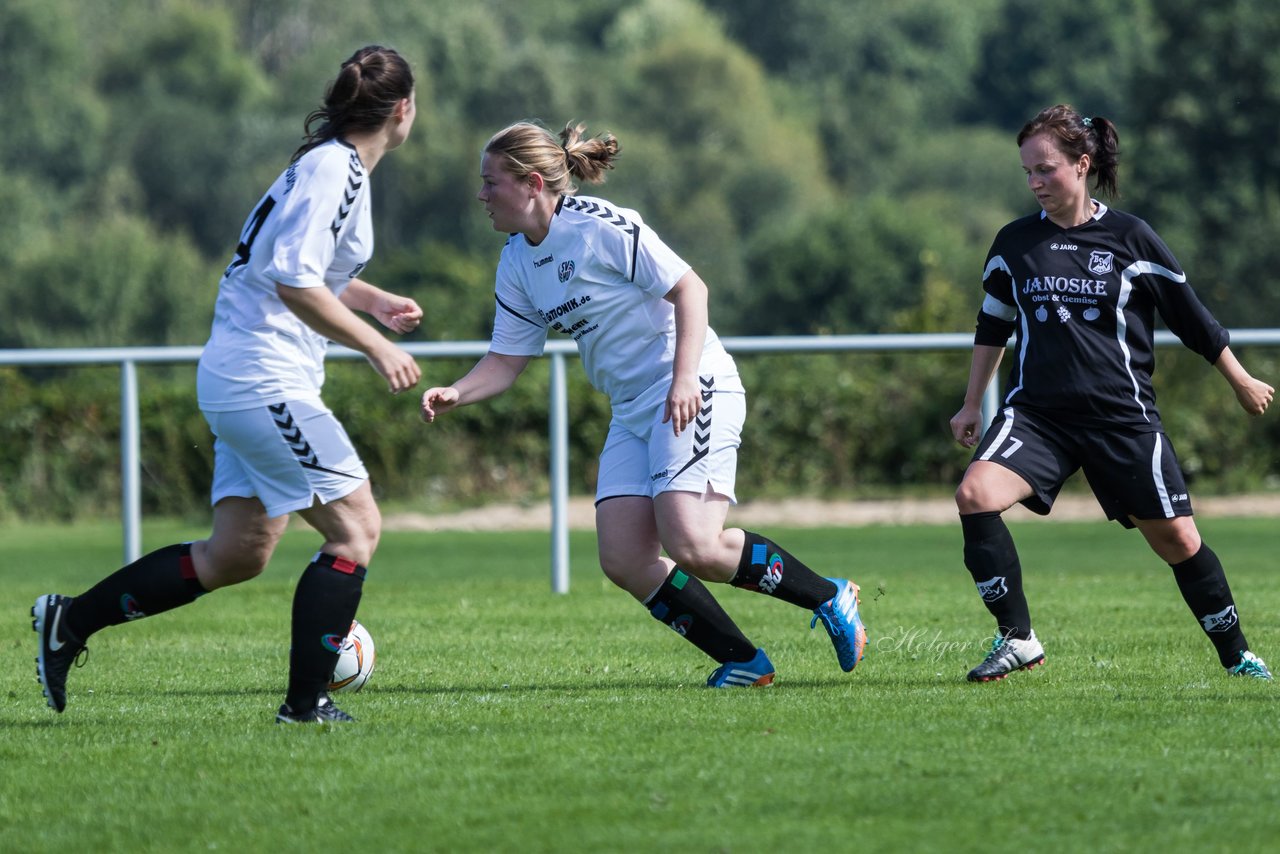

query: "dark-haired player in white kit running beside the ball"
(32, 45), (422, 723)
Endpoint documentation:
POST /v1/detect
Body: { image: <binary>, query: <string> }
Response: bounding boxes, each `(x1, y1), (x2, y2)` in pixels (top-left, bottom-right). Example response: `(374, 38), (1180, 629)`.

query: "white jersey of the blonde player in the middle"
(490, 190), (742, 419)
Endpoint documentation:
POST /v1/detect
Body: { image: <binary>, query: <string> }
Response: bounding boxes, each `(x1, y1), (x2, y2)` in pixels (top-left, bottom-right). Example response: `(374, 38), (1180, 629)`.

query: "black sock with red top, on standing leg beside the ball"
(284, 552), (367, 713)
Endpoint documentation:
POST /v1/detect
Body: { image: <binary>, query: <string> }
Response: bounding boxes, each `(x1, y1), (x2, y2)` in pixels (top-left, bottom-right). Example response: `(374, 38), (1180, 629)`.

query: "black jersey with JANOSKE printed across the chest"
(974, 202), (1228, 431)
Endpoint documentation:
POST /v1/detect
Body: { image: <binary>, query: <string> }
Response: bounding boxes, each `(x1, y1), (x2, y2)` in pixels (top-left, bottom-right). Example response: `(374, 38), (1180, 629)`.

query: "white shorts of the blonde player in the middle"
(595, 378), (746, 503)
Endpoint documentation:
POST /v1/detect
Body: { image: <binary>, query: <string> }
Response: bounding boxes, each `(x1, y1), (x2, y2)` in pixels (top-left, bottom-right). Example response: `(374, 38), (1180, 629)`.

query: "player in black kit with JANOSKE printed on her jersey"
(951, 105), (1275, 682)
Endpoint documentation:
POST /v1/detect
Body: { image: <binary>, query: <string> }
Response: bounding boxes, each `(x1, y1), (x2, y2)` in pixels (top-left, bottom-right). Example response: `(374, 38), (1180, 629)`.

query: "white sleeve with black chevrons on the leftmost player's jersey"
(264, 149), (348, 288)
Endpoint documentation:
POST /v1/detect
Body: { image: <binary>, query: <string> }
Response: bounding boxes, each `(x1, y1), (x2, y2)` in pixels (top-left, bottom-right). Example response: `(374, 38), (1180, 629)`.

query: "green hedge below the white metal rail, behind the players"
(0, 347), (1280, 520)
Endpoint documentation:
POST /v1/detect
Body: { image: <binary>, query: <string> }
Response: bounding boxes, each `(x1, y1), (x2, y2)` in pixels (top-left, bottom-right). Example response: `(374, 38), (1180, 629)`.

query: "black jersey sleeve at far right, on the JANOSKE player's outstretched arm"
(1123, 223), (1230, 364)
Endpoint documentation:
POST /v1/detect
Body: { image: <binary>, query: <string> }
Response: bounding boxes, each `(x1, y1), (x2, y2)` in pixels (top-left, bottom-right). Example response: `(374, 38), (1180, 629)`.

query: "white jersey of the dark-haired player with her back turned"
(196, 140), (374, 412)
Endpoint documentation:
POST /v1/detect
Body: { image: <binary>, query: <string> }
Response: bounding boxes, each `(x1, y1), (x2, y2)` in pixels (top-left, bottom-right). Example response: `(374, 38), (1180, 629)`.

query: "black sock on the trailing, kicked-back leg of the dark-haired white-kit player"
(65, 543), (205, 643)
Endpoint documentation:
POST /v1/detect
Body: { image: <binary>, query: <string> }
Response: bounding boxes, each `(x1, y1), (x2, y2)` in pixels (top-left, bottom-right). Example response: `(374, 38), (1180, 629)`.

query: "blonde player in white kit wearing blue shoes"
(422, 122), (867, 688)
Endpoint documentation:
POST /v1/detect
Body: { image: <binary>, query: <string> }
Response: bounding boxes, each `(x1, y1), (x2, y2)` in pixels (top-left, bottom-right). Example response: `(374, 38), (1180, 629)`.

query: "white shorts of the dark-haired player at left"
(204, 401), (369, 516)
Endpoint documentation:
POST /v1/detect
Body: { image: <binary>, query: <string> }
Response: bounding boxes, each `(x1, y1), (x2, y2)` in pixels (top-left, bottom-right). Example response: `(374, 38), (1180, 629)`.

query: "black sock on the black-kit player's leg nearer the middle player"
(960, 513), (1032, 640)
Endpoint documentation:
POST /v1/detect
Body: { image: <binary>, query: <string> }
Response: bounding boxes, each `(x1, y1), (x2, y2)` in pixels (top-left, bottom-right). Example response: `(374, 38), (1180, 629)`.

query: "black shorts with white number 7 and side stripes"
(973, 406), (1192, 528)
